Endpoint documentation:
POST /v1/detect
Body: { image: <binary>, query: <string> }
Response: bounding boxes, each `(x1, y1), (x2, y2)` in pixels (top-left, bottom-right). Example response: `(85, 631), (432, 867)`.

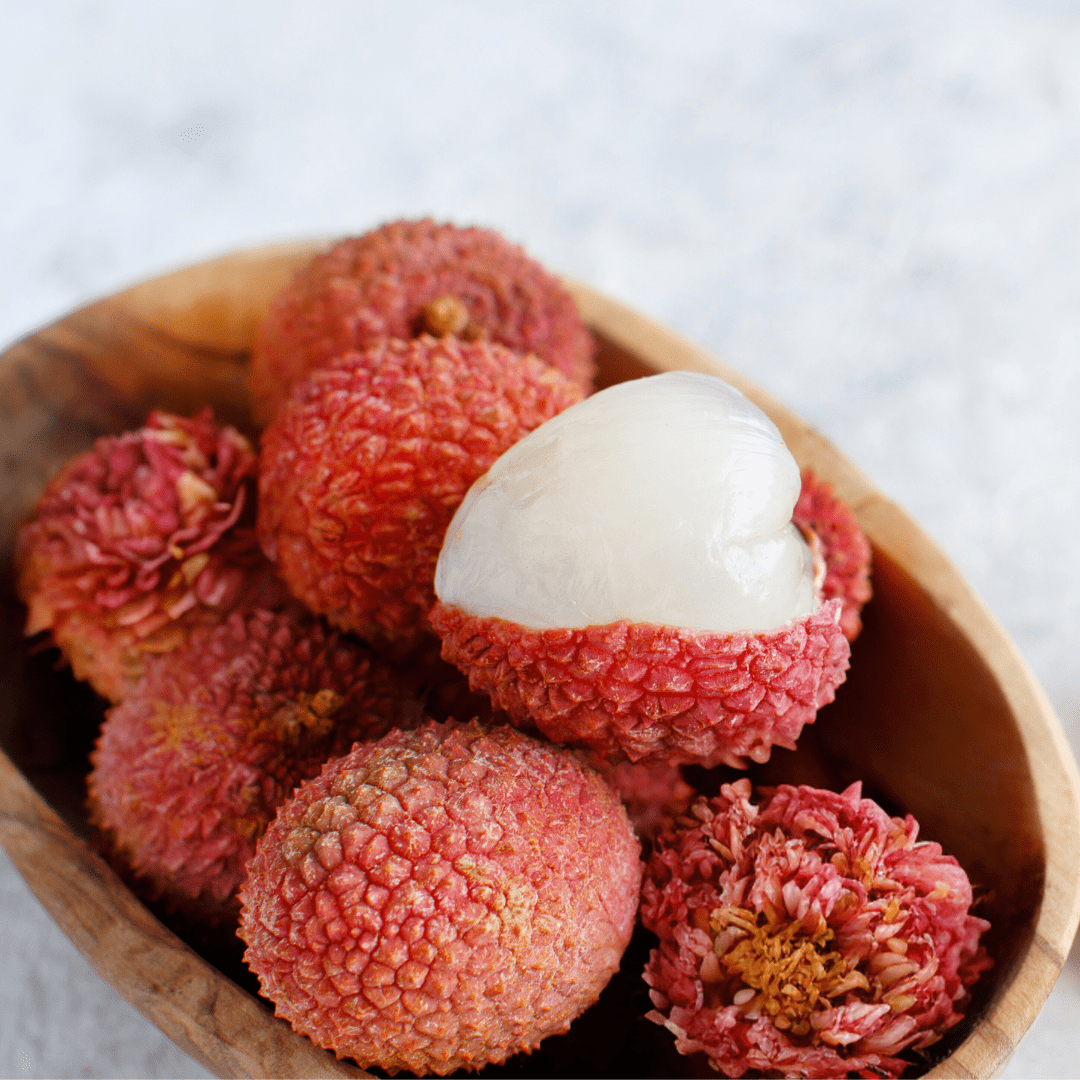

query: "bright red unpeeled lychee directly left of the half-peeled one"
(258, 336), (581, 647)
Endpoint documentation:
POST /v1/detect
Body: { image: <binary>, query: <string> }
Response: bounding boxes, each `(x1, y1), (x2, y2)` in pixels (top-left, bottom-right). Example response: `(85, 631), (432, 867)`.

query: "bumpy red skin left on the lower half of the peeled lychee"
(431, 599), (851, 768)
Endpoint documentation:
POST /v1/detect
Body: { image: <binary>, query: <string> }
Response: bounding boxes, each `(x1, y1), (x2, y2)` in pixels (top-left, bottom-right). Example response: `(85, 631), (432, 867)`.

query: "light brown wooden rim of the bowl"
(0, 241), (1080, 1077)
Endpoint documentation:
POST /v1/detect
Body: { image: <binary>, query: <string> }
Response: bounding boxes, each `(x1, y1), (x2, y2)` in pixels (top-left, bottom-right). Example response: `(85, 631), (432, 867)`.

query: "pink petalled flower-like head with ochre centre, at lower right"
(642, 780), (991, 1077)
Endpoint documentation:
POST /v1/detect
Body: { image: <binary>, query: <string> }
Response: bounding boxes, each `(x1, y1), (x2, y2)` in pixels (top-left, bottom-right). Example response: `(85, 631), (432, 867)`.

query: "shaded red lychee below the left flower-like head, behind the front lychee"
(89, 606), (422, 916)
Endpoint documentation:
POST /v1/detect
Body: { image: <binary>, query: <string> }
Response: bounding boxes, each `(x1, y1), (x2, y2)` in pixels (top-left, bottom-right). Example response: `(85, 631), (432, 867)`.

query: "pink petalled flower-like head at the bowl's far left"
(15, 408), (286, 701)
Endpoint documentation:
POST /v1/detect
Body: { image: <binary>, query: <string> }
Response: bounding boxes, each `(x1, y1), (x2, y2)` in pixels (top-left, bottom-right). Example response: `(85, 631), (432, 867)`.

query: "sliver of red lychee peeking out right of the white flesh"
(792, 469), (873, 642)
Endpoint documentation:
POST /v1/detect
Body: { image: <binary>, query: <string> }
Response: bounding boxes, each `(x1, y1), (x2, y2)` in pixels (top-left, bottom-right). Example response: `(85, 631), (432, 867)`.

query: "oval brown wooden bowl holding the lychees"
(0, 243), (1080, 1077)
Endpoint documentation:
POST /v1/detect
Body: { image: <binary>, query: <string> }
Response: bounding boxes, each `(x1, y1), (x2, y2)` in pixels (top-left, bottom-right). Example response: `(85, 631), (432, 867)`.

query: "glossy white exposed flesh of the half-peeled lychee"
(435, 372), (816, 633)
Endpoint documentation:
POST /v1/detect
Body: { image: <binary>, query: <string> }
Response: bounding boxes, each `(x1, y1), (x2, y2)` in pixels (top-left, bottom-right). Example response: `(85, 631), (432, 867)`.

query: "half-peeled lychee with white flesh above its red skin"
(430, 372), (849, 767)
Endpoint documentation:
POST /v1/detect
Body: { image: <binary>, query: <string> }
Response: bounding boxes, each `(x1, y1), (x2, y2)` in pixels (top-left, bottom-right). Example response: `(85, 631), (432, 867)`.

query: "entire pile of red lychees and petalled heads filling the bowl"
(18, 220), (989, 1077)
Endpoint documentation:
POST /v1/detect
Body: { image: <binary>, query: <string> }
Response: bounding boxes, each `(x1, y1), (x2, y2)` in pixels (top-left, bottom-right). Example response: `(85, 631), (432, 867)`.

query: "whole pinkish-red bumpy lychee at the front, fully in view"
(239, 723), (640, 1075)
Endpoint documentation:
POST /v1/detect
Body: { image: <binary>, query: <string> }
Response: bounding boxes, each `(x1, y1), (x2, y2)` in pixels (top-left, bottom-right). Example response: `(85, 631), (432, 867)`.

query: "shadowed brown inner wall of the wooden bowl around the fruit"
(0, 245), (1062, 1076)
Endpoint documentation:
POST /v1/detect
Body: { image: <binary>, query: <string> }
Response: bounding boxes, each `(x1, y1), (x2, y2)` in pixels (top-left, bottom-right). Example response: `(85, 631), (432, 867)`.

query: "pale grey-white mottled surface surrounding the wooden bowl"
(0, 0), (1080, 1077)
